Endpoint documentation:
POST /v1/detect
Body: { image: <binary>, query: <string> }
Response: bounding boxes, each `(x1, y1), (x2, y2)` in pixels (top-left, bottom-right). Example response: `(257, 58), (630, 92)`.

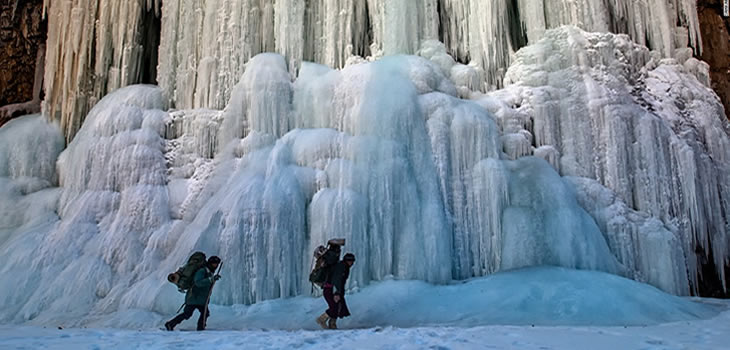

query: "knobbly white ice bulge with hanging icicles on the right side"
(480, 27), (730, 293)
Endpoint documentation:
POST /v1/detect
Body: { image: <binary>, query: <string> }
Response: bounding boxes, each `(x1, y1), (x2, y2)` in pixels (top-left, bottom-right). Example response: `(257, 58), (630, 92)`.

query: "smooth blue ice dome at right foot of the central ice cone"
(494, 157), (625, 274)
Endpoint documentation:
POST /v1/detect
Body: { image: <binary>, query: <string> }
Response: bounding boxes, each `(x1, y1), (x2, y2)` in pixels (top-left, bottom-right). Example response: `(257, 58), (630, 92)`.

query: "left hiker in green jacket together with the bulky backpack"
(165, 252), (221, 331)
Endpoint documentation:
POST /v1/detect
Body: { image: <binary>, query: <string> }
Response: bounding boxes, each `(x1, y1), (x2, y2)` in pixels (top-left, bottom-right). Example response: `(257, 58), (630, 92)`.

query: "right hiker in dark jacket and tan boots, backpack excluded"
(317, 253), (355, 329)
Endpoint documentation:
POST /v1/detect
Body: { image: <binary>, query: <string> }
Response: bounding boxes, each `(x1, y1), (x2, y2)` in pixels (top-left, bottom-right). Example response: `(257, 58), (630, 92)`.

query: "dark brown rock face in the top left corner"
(0, 0), (47, 125)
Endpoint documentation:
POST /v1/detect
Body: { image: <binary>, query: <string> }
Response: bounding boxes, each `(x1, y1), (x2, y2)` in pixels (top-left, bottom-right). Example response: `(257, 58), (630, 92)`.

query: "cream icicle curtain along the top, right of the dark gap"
(159, 0), (701, 112)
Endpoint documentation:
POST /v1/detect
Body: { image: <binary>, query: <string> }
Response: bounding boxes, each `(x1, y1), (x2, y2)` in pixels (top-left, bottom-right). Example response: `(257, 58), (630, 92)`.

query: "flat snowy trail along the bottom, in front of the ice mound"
(0, 311), (730, 350)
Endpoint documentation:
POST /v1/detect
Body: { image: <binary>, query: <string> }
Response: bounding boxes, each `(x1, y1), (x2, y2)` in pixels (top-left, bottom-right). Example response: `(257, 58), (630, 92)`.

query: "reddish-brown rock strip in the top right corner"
(697, 0), (730, 119)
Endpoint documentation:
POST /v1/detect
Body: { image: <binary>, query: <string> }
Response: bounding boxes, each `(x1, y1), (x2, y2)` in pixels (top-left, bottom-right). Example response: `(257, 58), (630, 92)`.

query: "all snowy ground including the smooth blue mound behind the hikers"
(0, 267), (730, 350)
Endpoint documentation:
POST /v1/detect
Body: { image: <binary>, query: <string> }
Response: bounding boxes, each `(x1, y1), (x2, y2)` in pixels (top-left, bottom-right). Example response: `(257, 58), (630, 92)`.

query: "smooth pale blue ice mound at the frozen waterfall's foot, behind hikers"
(99, 265), (721, 330)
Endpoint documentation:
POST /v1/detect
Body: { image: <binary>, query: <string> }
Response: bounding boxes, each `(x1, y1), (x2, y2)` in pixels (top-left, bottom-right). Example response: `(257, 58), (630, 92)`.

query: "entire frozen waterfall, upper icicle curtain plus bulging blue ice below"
(0, 6), (730, 325)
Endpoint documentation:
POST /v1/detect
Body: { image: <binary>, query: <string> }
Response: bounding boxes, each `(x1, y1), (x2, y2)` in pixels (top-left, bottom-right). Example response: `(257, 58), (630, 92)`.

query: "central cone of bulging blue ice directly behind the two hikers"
(157, 50), (623, 303)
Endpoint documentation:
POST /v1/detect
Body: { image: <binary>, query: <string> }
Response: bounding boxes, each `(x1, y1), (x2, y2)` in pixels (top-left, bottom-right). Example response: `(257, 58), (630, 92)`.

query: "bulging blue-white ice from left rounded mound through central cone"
(3, 55), (621, 323)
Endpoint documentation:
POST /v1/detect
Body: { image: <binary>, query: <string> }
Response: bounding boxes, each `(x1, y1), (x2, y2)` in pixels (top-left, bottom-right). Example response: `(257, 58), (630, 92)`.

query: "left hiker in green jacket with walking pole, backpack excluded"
(165, 256), (221, 331)
